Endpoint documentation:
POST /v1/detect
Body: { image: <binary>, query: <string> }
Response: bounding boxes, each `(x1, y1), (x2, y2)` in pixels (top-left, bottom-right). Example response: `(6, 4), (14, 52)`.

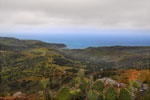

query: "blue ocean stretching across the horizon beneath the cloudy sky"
(0, 33), (150, 49)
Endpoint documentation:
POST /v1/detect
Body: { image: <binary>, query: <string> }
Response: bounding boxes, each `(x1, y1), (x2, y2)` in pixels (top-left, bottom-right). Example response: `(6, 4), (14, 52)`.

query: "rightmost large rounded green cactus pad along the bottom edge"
(119, 88), (133, 100)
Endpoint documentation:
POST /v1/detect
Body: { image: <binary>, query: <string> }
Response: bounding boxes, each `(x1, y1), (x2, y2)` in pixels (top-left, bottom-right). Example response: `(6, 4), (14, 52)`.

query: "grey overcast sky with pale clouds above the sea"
(0, 0), (150, 33)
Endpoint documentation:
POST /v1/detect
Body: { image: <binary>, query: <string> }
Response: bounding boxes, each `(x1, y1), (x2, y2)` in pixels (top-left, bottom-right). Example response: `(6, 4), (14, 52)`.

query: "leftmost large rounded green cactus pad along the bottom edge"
(57, 87), (71, 100)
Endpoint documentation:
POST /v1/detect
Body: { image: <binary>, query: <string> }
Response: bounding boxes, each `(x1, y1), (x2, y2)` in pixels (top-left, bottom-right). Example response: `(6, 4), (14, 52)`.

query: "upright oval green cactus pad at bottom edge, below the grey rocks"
(106, 87), (117, 100)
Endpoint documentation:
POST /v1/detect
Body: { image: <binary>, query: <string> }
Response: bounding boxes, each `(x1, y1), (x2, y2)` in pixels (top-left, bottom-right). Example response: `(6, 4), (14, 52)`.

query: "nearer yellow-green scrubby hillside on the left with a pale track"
(0, 48), (80, 91)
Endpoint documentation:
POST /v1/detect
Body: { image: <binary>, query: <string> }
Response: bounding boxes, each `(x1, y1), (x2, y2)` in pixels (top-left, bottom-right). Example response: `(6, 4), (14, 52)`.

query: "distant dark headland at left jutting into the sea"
(0, 37), (66, 51)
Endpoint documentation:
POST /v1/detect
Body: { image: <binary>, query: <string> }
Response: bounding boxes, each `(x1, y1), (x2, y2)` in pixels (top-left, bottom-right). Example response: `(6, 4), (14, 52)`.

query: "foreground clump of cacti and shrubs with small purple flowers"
(38, 69), (150, 100)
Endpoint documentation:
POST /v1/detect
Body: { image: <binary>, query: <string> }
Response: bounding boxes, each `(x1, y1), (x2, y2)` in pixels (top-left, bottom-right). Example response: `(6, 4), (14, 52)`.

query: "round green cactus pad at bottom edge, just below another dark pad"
(87, 90), (100, 100)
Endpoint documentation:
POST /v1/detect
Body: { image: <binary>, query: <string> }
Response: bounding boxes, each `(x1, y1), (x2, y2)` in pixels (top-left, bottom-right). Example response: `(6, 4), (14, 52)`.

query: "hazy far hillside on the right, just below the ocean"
(62, 46), (150, 69)
